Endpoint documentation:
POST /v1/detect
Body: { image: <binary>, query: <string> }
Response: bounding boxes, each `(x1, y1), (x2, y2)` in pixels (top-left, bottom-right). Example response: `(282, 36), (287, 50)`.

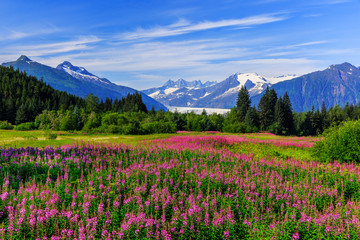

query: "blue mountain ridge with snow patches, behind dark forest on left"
(2, 55), (167, 110)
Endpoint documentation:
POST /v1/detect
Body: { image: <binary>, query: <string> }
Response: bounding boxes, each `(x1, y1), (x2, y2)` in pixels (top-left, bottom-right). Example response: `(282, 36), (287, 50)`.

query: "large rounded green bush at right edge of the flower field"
(314, 121), (360, 162)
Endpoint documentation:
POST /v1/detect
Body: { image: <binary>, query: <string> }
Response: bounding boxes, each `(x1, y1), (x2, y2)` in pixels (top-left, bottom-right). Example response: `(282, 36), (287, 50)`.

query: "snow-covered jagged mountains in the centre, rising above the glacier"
(143, 73), (297, 108)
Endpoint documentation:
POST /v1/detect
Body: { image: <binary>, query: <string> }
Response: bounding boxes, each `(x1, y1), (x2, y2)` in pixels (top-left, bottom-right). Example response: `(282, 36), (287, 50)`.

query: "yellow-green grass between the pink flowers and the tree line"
(0, 130), (318, 159)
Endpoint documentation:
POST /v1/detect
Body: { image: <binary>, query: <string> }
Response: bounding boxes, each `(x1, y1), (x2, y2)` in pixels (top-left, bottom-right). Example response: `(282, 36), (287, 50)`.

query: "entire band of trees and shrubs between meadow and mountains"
(0, 66), (360, 136)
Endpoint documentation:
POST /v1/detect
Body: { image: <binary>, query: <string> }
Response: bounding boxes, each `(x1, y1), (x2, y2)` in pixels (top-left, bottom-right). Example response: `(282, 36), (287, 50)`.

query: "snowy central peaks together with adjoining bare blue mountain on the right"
(143, 62), (360, 112)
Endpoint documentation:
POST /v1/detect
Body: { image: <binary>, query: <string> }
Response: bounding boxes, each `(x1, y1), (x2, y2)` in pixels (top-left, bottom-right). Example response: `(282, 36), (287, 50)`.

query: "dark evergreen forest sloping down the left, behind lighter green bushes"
(0, 66), (147, 125)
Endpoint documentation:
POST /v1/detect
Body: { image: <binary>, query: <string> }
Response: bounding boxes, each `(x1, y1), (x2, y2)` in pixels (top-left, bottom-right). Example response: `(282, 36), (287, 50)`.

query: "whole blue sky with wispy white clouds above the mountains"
(0, 0), (360, 89)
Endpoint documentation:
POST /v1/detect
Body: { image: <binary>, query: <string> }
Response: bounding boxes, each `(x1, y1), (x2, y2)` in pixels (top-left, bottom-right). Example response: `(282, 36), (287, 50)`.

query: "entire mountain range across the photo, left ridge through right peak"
(2, 55), (360, 112)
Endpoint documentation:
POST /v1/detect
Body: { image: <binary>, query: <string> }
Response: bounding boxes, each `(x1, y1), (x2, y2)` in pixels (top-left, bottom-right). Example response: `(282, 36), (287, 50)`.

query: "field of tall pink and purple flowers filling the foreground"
(0, 136), (360, 239)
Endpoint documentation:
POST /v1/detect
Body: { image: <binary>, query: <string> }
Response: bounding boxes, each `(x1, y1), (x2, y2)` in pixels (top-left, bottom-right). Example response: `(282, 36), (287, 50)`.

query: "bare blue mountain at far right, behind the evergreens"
(252, 63), (360, 112)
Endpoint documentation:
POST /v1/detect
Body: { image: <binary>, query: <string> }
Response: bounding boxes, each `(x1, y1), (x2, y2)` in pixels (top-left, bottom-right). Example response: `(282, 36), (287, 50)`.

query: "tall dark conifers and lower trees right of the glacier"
(230, 86), (360, 136)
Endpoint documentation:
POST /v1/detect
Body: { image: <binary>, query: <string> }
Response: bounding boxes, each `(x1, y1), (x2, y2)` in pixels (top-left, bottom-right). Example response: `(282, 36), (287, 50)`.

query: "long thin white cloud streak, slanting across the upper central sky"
(119, 15), (286, 40)
